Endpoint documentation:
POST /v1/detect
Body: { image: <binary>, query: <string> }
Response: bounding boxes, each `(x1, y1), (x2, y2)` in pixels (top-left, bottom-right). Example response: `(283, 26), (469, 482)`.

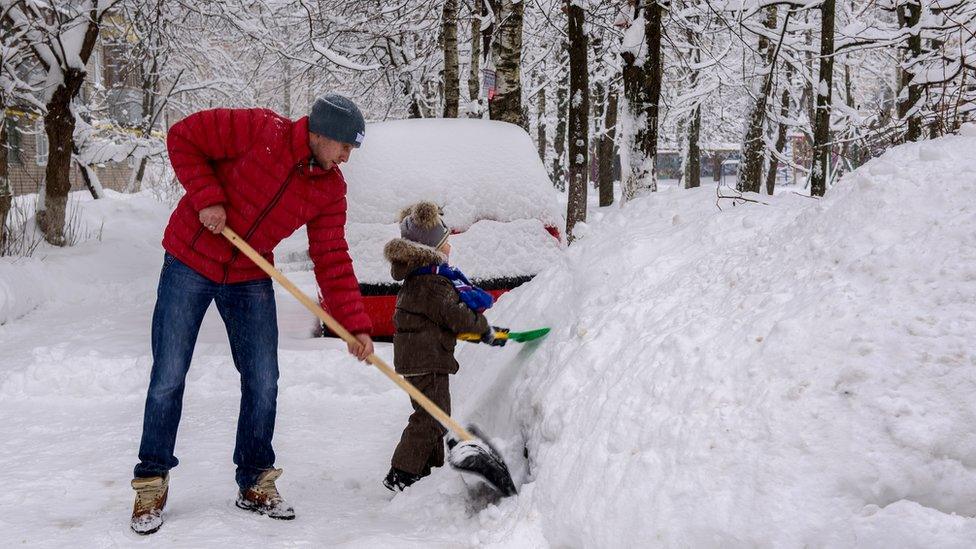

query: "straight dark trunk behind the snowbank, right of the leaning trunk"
(810, 0), (836, 196)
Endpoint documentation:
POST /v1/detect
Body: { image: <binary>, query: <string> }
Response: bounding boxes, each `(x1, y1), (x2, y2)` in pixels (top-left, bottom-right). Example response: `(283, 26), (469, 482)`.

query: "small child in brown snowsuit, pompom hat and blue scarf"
(383, 202), (506, 491)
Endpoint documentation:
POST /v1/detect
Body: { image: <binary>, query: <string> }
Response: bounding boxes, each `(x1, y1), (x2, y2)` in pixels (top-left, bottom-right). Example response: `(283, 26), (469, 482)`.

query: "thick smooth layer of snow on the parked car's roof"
(342, 118), (563, 231)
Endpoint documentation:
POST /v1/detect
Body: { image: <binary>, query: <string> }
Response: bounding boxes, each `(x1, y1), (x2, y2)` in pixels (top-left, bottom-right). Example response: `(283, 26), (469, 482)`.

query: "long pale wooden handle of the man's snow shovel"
(221, 227), (474, 441)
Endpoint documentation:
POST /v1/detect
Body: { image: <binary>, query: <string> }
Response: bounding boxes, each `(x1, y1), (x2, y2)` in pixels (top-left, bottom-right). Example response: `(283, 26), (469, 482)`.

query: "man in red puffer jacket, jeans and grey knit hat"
(131, 94), (373, 534)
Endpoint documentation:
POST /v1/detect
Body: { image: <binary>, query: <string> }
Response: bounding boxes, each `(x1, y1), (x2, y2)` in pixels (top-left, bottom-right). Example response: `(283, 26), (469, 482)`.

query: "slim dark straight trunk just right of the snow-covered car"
(565, 0), (590, 243)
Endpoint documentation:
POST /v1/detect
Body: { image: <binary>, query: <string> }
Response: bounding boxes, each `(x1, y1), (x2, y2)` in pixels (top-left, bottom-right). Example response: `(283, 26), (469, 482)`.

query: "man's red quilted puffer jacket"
(163, 105), (372, 333)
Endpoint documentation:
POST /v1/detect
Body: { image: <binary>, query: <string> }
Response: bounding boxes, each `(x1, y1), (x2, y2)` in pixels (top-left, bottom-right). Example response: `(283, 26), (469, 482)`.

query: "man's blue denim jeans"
(134, 254), (278, 489)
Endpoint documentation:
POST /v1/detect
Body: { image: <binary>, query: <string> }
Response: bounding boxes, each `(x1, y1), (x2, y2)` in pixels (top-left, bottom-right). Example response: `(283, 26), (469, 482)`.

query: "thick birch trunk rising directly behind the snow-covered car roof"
(488, 0), (529, 131)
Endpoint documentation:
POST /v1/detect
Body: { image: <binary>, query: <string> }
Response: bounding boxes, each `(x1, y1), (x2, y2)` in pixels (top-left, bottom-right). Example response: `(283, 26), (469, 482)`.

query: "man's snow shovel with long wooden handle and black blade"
(221, 227), (518, 497)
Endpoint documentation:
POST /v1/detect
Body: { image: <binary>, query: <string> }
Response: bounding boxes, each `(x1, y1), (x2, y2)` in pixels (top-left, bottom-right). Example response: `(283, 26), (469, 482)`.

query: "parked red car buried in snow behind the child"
(320, 119), (564, 336)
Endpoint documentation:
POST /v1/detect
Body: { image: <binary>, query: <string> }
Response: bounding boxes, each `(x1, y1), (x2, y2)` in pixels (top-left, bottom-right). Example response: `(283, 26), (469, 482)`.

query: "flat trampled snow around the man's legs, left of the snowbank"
(0, 195), (488, 547)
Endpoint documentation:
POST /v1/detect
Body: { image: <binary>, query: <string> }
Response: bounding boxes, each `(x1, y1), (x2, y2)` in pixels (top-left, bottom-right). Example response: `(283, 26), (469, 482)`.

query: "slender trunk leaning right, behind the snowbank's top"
(736, 6), (786, 193)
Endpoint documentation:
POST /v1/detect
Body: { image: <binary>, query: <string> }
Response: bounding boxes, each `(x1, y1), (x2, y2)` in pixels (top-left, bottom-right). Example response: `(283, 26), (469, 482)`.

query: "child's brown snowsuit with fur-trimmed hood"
(383, 238), (490, 475)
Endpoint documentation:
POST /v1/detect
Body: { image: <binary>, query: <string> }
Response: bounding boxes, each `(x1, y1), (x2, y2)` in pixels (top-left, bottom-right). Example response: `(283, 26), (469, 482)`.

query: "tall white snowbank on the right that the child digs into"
(430, 132), (976, 547)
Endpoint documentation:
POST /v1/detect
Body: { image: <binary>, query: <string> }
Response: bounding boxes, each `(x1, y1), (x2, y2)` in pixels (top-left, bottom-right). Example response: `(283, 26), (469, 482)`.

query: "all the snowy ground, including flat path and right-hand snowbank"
(0, 131), (976, 547)
